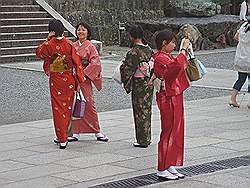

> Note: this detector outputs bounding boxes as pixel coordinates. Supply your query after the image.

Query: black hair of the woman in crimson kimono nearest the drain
[155,30,176,50]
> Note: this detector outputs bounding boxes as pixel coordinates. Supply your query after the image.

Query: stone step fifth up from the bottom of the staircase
[0,24,48,33]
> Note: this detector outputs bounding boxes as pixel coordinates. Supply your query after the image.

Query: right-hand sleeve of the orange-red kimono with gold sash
[72,46,85,83]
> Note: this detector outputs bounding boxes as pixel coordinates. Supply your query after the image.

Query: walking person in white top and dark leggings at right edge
[229,16,250,108]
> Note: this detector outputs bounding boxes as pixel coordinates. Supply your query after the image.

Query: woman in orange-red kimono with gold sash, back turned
[36,20,85,149]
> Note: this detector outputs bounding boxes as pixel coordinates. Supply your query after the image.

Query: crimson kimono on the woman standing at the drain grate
[153,52,189,171]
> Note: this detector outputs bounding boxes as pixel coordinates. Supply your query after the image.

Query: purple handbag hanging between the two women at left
[72,90,86,118]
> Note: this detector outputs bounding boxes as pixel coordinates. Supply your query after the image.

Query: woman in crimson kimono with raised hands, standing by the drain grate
[153,30,190,180]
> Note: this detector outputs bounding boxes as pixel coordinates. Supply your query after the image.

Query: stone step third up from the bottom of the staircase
[0,39,45,48]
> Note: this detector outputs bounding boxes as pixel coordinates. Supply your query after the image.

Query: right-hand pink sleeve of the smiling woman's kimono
[84,45,102,81]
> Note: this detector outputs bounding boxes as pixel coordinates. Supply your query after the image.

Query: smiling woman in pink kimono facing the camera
[71,23,108,142]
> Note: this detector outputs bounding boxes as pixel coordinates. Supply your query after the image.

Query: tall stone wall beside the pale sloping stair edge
[46,0,164,45]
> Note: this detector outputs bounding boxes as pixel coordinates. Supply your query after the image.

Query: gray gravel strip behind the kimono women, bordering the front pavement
[0,68,229,125]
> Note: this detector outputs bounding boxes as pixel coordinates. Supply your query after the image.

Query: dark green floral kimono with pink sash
[120,45,154,146]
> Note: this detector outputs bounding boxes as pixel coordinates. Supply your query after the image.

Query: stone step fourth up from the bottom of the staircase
[0,31,48,40]
